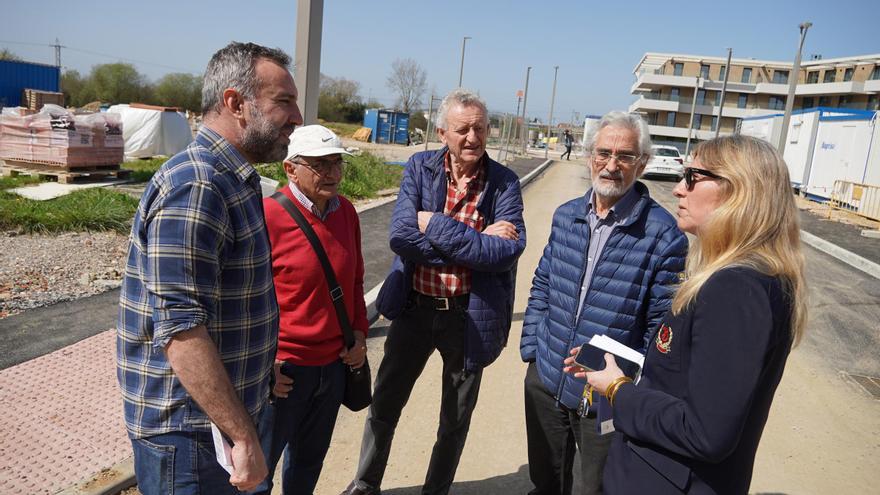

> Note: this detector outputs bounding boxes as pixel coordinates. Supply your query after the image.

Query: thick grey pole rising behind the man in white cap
[294,0,324,125]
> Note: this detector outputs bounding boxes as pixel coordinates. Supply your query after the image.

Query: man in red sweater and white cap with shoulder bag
[255,125,369,494]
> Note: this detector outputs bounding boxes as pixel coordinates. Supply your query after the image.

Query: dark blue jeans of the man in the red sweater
[253,360,346,495]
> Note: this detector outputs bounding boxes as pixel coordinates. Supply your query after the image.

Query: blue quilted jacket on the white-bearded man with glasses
[520,182,687,409]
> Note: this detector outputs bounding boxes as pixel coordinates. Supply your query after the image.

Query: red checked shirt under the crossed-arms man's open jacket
[413,153,486,297]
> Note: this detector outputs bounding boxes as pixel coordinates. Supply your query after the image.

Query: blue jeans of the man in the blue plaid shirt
[131,431,240,495]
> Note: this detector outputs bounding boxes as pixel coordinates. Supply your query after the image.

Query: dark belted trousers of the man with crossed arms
[355,305,482,494]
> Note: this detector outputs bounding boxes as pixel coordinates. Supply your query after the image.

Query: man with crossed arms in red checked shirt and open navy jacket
[343,89,526,495]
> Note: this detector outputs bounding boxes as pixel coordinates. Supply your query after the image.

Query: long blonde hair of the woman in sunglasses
[672,135,807,345]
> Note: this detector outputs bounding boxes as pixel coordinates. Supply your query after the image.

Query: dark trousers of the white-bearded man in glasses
[525,363,612,495]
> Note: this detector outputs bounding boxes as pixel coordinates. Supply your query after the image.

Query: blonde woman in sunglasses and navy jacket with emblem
[566,136,807,494]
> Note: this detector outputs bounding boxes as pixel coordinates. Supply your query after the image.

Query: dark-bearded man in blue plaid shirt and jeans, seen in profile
[116,42,302,495]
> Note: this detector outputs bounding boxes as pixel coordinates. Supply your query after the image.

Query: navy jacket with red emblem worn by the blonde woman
[604,267,791,495]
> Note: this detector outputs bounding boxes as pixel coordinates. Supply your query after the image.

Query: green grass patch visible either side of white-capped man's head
[257,152,403,199]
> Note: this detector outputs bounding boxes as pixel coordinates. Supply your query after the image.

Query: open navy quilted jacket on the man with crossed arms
[376,147,526,371]
